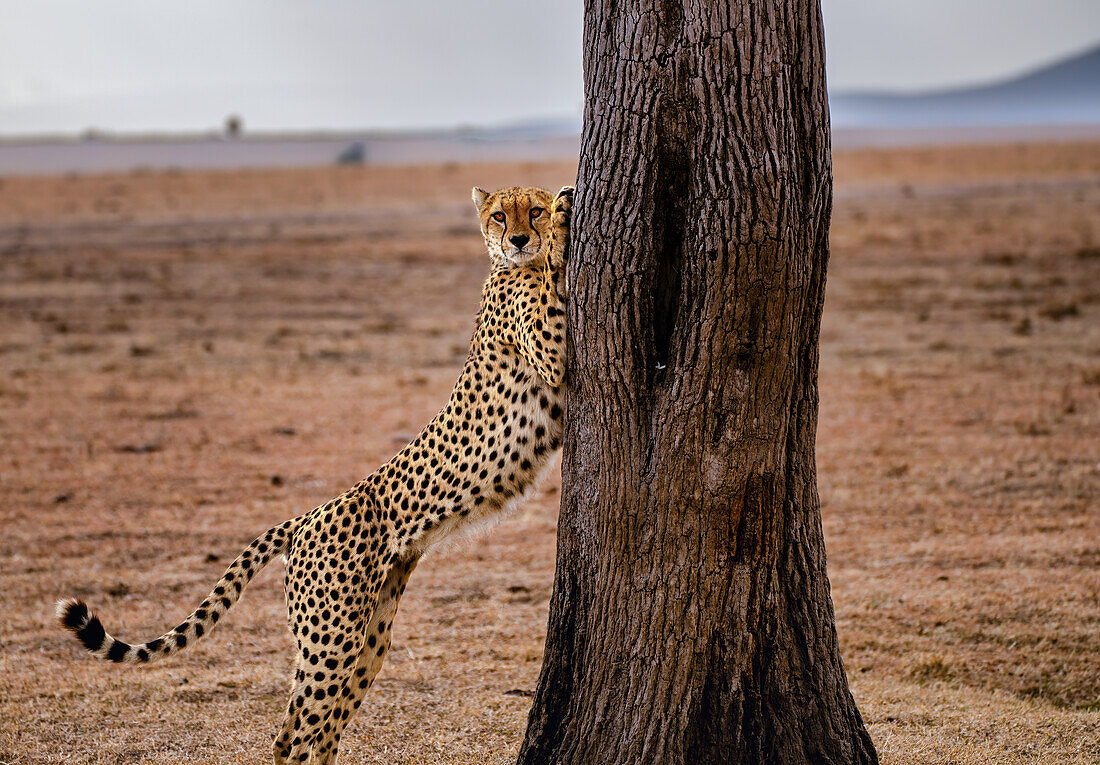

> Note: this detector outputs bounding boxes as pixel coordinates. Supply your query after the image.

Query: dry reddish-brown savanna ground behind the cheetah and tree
[0,142,1100,765]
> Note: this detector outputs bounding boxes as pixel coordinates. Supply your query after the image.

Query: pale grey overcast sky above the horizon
[0,0,1100,134]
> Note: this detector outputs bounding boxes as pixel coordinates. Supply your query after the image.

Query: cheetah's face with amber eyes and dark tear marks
[473,186,553,266]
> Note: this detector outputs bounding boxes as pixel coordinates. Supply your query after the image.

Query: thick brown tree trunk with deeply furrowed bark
[519,0,877,765]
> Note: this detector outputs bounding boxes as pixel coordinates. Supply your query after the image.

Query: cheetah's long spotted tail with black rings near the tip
[57,518,298,664]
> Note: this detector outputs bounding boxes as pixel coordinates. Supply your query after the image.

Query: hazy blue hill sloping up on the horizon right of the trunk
[829,45,1100,128]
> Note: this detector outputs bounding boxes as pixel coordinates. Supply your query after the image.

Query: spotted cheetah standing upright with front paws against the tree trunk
[58,186,573,765]
